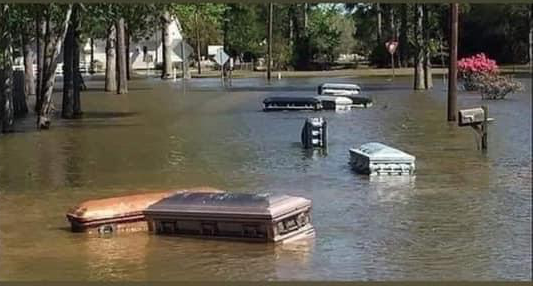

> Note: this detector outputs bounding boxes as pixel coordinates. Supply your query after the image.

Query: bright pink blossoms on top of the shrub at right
[457,53,499,91]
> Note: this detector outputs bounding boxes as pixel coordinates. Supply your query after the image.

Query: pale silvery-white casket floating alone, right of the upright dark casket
[350,142,415,175]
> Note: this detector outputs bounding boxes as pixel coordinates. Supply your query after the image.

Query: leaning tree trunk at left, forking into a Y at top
[37,4,72,129]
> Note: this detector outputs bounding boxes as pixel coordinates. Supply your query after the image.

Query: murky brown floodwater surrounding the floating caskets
[0,72,532,280]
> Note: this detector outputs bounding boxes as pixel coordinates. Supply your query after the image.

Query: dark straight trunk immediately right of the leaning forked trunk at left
[61,21,74,119]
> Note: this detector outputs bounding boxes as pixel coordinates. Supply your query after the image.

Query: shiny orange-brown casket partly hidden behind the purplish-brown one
[66,187,223,233]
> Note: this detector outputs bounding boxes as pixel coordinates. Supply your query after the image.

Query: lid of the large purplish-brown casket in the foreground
[145,192,311,218]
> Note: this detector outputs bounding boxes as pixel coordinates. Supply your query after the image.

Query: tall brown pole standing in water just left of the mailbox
[448,3,459,121]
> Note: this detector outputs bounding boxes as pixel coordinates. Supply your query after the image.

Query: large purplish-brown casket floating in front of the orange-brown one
[144,193,314,242]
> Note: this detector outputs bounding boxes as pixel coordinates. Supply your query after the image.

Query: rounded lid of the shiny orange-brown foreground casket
[67,187,223,222]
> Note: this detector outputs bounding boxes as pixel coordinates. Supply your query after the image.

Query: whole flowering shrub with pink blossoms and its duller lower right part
[457,53,522,99]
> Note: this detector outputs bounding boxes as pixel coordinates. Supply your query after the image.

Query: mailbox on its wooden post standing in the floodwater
[458,106,494,150]
